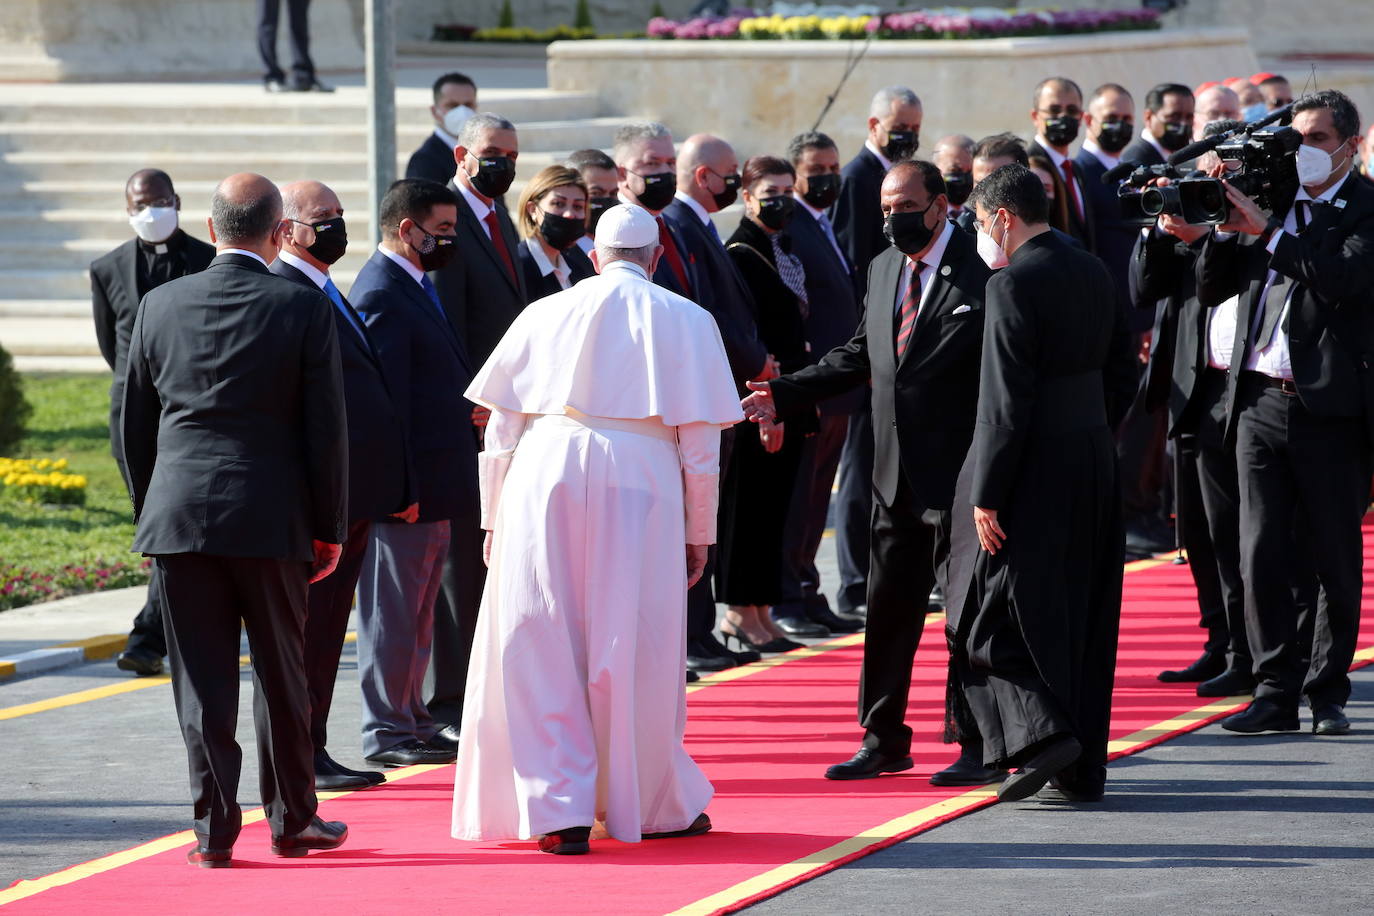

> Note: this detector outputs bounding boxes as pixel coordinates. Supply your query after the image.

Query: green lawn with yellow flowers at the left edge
[0,374,146,610]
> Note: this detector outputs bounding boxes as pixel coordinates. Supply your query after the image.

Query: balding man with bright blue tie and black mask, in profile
[268,181,419,790]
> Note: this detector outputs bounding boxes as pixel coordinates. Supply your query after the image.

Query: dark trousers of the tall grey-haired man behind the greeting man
[835,396,872,611]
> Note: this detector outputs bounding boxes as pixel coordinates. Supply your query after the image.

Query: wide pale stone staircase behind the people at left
[0,76,622,372]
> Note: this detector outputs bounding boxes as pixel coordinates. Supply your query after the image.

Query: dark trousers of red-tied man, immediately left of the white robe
[425,515,486,728]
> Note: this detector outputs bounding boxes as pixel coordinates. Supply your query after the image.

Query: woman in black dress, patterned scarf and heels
[716,157,818,652]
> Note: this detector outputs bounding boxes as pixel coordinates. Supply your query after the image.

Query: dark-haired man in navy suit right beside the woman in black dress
[774,130,864,633]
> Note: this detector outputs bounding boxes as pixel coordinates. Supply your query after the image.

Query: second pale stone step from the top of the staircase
[0,114,624,155]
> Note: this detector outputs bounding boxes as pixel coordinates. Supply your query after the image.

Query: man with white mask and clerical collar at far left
[91,169,214,677]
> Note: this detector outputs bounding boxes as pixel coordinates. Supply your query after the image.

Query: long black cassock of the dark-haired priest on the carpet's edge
[949,232,1136,788]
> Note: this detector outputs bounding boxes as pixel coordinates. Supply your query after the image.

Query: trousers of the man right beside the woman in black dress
[772,413,849,617]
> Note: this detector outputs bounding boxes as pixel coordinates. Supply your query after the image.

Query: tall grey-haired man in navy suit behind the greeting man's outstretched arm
[830,87,923,617]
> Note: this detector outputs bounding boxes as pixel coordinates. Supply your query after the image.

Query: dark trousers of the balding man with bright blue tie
[305,519,372,753]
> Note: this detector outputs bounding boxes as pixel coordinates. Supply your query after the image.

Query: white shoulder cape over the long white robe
[467,262,743,426]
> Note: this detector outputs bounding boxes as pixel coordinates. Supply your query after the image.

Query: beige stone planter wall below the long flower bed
[548,29,1259,158]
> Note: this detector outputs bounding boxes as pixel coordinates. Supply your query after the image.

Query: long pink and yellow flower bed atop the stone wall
[647,10,1160,41]
